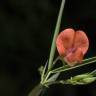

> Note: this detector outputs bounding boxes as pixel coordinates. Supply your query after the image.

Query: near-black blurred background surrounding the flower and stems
[0,0,96,96]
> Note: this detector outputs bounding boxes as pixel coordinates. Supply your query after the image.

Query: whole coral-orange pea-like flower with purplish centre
[56,28,89,66]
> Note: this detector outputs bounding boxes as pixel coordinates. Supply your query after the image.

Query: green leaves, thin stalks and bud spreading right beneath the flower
[39,57,96,87]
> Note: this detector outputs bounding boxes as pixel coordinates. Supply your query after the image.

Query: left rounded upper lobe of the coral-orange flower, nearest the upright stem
[56,28,75,56]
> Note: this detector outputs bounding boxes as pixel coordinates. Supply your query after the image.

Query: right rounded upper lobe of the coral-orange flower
[74,31,89,54]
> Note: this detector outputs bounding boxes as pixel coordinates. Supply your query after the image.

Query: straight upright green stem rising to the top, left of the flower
[48,0,65,70]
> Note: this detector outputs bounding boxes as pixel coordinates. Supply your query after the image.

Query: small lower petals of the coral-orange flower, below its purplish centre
[64,48,83,66]
